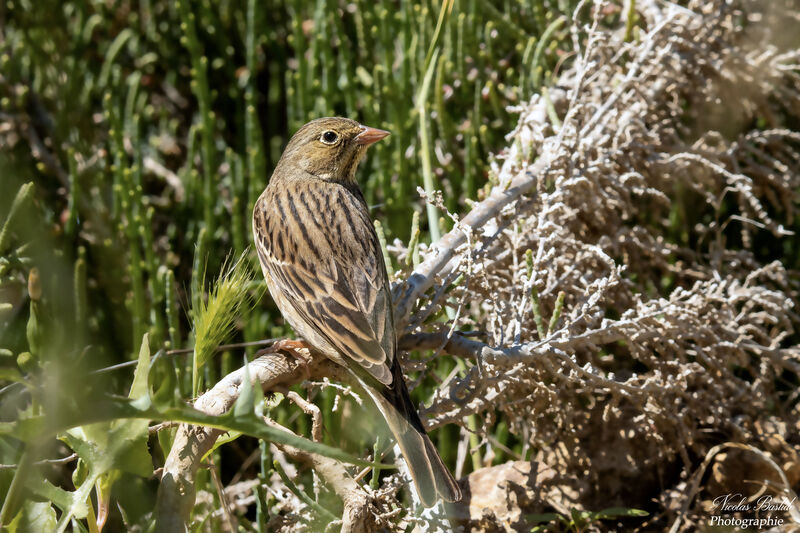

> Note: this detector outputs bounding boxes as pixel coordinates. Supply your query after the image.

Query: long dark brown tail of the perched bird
[362,375,461,507]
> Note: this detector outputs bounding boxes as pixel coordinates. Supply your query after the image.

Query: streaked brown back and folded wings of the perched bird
[254,182,395,385]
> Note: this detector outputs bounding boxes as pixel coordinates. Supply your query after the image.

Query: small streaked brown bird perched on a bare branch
[253,118,461,507]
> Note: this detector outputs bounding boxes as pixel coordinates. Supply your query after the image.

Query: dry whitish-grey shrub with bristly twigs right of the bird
[391,1,800,529]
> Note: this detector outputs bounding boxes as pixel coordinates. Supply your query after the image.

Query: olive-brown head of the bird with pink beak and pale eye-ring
[279,117,389,183]
